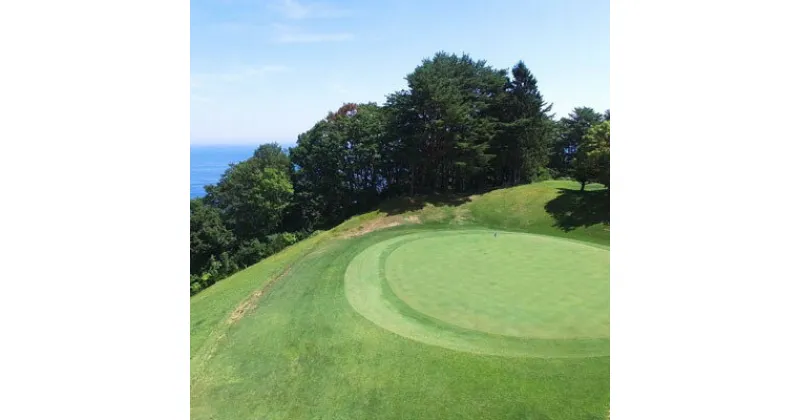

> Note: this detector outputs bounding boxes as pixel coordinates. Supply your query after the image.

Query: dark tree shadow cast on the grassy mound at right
[544,188,611,232]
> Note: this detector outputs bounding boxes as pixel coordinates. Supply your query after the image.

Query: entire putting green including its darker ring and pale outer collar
[345,230,609,357]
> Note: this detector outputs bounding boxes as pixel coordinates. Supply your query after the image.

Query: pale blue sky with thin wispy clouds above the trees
[191,0,610,145]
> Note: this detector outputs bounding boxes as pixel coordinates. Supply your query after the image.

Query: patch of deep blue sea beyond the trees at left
[189,145,258,198]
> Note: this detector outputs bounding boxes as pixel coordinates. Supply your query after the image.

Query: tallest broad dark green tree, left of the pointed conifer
[387,52,507,195]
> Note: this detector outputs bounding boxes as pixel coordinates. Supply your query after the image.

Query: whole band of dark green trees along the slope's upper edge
[190,52,611,294]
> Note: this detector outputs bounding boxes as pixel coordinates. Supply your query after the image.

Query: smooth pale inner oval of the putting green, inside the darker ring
[384,232,609,339]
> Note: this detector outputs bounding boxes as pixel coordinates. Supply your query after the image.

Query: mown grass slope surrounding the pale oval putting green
[191,181,609,419]
